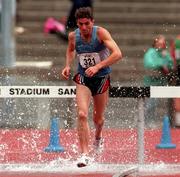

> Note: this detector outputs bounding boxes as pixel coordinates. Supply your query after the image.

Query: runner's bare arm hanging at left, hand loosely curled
[62,32,75,79]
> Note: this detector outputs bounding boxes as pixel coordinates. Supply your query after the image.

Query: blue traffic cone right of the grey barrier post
[156,116,176,149]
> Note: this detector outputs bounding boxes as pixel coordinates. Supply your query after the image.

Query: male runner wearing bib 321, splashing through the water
[62,7,122,167]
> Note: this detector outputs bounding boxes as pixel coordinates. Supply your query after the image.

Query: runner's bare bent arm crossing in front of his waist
[86,27,122,77]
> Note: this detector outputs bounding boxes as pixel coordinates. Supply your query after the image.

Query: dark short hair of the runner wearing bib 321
[75,7,93,20]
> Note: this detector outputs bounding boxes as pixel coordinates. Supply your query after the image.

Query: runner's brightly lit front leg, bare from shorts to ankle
[76,84,91,153]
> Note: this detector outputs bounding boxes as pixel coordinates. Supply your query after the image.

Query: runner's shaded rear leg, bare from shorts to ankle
[93,90,109,139]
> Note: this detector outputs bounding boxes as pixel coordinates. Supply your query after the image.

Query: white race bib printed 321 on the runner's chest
[77,53,101,68]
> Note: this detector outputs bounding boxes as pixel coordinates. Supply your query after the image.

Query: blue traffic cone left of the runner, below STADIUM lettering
[44,118,64,152]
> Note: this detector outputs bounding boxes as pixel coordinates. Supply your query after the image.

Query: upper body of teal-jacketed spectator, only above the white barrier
[144,35,173,86]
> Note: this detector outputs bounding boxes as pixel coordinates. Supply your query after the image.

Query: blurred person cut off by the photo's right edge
[171,35,180,127]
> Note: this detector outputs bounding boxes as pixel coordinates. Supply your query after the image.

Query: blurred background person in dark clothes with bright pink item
[44,0,93,40]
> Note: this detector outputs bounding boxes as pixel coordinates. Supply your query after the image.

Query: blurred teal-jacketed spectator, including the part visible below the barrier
[144,35,173,128]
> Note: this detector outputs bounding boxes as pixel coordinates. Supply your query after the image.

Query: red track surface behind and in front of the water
[0,129,180,177]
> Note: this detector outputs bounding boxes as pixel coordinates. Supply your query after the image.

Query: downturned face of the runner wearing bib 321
[77,18,94,36]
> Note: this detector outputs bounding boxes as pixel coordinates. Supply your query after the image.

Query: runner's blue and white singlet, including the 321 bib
[75,26,111,77]
